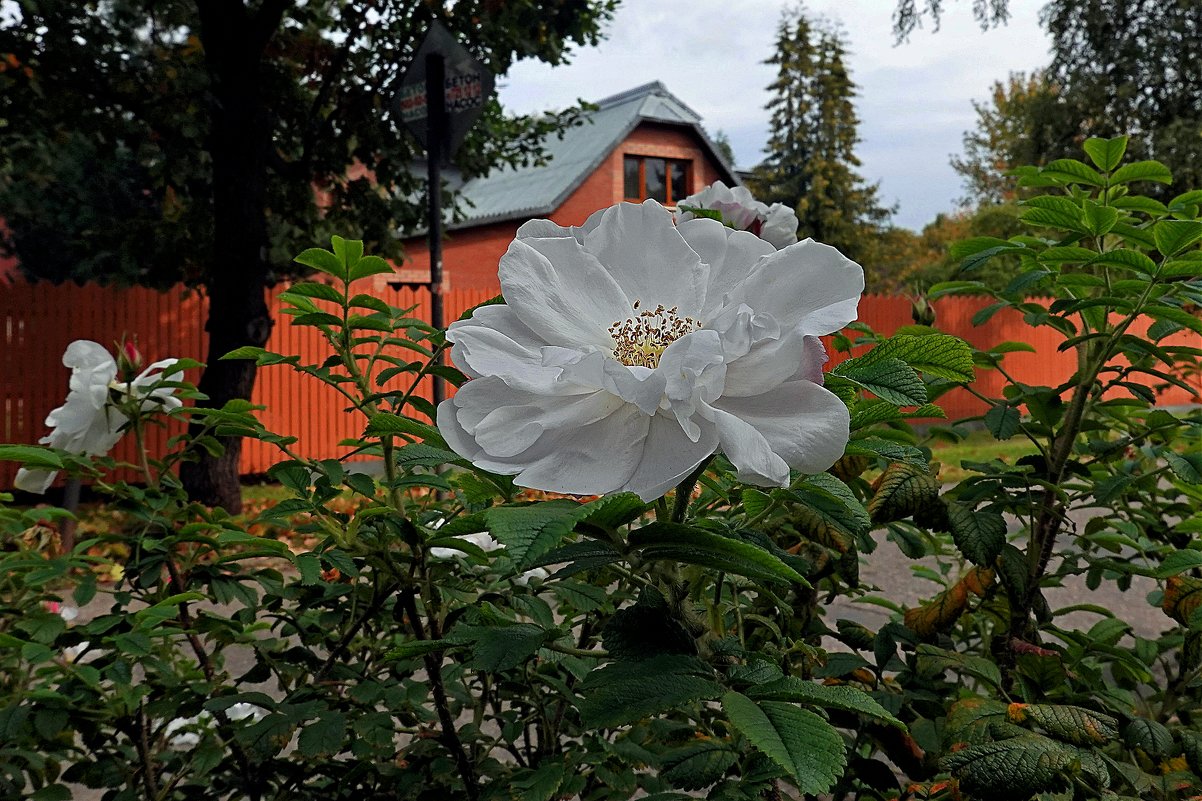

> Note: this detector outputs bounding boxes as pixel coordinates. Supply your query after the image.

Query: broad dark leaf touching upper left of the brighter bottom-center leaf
[579,654,722,729]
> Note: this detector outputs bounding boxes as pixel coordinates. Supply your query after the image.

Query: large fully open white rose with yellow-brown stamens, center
[438,201,864,500]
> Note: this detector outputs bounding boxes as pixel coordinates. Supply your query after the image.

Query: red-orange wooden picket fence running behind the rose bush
[0,277,1202,488]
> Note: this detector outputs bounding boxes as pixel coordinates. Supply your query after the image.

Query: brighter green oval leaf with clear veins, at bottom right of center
[722,693,847,795]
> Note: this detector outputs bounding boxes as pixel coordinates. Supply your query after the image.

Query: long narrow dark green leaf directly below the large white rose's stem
[629,523,809,587]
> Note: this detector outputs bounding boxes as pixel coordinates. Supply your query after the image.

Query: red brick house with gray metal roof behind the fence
[380,82,742,291]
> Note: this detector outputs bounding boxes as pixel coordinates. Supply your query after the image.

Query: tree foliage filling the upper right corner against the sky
[952,0,1202,202]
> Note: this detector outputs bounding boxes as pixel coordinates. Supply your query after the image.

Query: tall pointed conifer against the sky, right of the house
[749,6,892,264]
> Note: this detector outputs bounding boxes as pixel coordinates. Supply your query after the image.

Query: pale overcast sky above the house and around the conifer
[499,0,1048,230]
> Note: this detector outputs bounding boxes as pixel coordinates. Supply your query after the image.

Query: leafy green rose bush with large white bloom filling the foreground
[0,146,1202,801]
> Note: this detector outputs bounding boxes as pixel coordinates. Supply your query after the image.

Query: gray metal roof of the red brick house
[447,81,742,230]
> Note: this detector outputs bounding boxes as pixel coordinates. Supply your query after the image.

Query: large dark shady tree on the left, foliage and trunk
[0,0,617,510]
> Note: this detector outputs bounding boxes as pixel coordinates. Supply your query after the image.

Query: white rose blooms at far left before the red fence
[13,339,183,493]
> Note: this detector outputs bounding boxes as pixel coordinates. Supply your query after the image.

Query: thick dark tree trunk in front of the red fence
[180,0,286,514]
